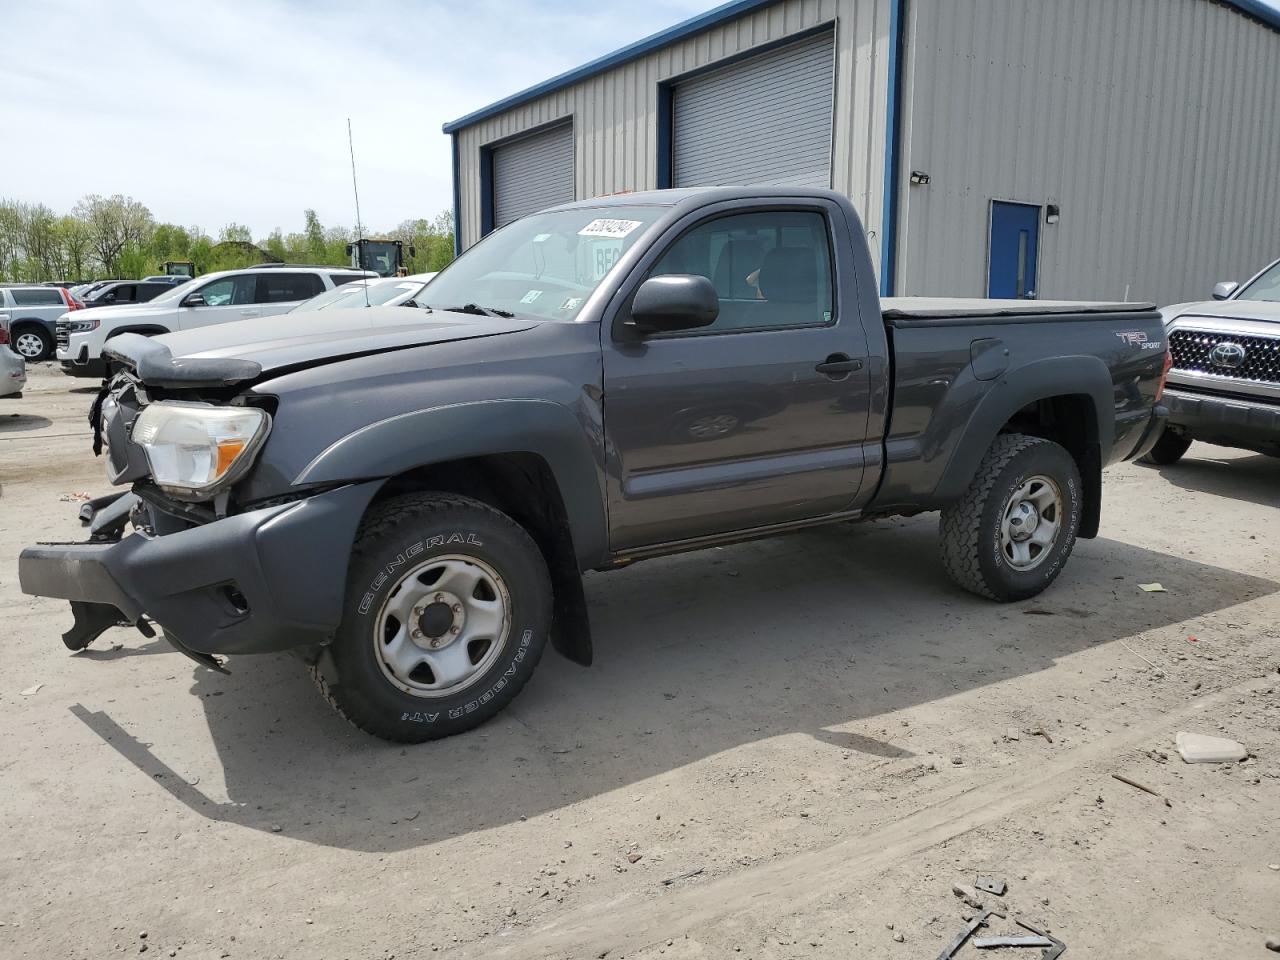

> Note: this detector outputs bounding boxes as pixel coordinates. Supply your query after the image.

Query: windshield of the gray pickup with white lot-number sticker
[419,206,664,320]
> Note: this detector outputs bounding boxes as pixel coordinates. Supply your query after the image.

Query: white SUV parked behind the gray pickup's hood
[56,265,376,376]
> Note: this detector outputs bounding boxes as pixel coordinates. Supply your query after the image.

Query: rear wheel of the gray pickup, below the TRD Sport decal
[940,434,1082,603]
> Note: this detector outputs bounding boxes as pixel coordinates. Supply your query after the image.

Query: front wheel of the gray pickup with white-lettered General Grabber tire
[312,494,552,742]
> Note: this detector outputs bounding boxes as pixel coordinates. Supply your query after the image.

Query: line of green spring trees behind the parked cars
[0,193,453,283]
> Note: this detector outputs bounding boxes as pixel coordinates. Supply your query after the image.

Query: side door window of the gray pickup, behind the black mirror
[649,210,835,335]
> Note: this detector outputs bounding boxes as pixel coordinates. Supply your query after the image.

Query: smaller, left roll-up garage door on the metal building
[493,123,573,227]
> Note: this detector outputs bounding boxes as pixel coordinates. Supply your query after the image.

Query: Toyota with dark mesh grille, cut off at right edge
[1147,260,1280,463]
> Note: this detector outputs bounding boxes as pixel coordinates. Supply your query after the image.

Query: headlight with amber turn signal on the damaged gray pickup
[133,401,271,498]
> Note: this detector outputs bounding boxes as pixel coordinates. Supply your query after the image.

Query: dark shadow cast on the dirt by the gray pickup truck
[73,517,1280,851]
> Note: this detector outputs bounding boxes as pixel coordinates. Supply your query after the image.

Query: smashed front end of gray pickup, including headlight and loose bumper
[19,334,379,669]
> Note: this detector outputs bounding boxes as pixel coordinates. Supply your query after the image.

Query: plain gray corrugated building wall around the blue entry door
[897,0,1280,303]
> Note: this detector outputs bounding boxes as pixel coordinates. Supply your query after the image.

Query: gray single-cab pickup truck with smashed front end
[20,188,1167,741]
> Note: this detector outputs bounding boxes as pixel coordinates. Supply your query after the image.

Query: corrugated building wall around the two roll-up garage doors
[457,0,890,257]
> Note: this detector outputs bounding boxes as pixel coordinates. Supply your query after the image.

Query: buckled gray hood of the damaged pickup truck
[104,307,538,387]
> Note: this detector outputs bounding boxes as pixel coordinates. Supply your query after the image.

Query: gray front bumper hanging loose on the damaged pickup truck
[18,481,381,654]
